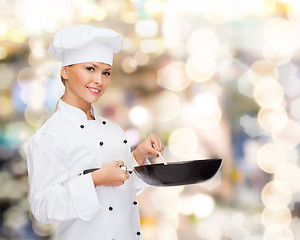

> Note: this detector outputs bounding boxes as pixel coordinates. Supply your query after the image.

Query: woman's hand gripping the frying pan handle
[91,161,129,187]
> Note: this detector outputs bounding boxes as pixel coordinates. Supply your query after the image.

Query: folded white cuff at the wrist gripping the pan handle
[68,173,101,221]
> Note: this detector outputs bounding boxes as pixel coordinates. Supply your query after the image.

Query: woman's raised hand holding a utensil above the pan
[132,133,164,165]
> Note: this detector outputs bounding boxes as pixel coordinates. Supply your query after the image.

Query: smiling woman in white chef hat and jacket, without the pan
[27,26,164,240]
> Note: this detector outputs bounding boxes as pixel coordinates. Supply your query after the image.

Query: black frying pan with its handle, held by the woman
[83,159,222,187]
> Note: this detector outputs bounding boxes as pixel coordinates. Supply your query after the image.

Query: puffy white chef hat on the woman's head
[48,25,123,66]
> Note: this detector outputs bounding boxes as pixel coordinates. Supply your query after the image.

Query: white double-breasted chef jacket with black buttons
[27,100,145,240]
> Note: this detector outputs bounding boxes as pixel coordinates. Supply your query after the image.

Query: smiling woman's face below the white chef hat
[61,62,111,104]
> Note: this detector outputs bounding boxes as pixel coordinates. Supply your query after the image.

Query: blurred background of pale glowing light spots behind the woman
[0,0,300,240]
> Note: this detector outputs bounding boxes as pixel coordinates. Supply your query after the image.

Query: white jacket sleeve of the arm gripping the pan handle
[27,134,101,223]
